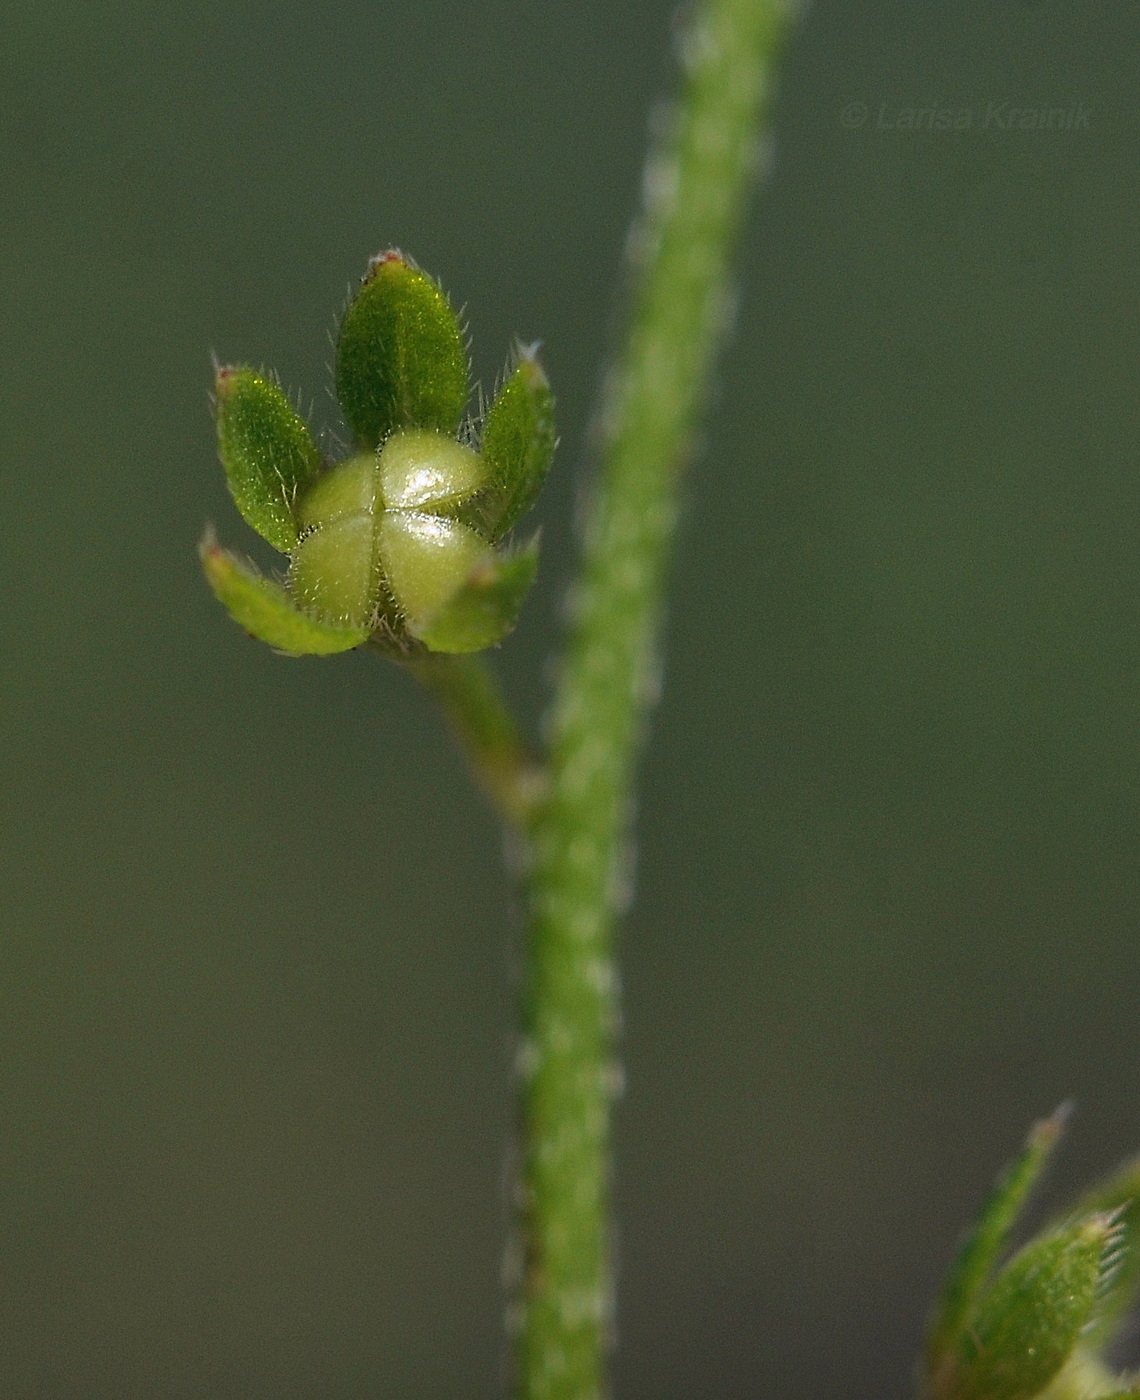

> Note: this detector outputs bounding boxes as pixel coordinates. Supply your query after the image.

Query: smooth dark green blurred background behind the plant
[0,0,1140,1400]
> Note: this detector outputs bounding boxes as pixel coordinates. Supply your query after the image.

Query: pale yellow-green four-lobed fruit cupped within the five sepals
[290,430,492,636]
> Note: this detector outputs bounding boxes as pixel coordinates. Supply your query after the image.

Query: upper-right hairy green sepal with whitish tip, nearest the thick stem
[482,346,555,539]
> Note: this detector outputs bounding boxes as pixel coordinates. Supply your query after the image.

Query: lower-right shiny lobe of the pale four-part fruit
[380,511,492,634]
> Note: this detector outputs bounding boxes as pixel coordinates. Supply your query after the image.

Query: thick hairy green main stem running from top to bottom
[517,0,783,1400]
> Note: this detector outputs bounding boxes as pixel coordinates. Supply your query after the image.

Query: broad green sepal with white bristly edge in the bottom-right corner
[944,1214,1120,1400]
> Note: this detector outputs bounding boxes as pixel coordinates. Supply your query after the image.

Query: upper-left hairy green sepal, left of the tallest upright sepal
[214,365,321,554]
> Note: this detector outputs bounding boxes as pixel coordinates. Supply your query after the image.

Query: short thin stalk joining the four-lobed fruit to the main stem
[401,651,545,832]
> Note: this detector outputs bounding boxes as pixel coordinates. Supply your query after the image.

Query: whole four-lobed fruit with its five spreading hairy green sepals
[210,249,555,661]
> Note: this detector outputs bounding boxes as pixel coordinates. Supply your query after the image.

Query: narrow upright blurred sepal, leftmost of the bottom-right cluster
[926,1105,1069,1389]
